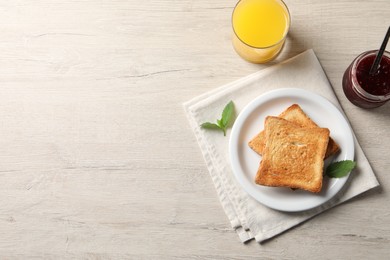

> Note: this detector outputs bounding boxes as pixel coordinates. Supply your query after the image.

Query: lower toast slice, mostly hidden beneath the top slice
[248,104,340,158]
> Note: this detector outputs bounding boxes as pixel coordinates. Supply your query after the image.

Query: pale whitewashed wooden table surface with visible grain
[0,0,390,259]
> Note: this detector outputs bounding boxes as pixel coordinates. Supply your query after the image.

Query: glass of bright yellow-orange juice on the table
[232,0,290,63]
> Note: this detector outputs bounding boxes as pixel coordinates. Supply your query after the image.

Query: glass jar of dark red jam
[343,50,390,108]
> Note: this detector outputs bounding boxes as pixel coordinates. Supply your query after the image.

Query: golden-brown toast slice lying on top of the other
[255,116,329,192]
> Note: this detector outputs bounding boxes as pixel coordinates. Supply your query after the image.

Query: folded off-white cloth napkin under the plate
[183,50,379,242]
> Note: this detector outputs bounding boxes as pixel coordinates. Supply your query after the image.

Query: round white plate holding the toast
[229,88,354,212]
